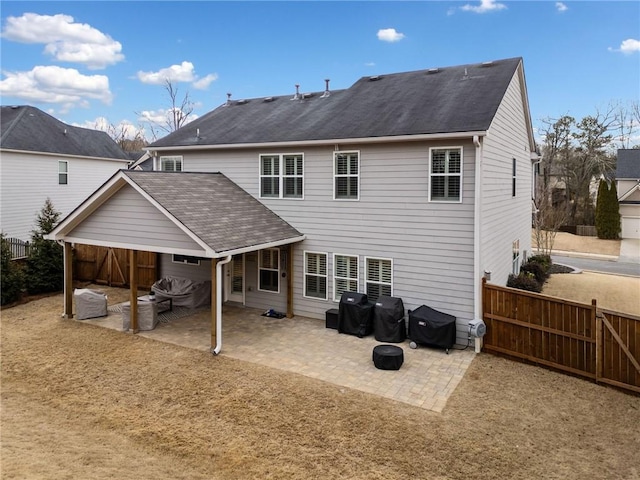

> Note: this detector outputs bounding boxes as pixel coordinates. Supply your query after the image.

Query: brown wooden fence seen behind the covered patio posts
[73,245,158,288]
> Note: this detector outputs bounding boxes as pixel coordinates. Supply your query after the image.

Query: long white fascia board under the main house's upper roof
[149,130,487,153]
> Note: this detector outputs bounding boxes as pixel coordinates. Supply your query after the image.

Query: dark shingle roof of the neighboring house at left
[0,105,129,160]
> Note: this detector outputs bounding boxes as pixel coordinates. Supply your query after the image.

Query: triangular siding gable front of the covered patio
[67,185,204,255]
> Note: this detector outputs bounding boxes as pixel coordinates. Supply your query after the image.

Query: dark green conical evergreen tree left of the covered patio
[26,198,64,294]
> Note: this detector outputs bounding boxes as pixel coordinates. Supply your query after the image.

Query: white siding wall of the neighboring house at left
[0,151,127,240]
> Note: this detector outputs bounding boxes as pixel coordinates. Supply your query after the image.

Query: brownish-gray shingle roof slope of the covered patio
[122,170,302,253]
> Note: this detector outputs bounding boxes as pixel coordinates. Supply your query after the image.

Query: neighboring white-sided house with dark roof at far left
[0,105,130,241]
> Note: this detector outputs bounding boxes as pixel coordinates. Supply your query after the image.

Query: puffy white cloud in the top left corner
[2,13,124,69]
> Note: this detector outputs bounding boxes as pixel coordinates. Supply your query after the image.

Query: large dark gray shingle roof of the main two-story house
[151,58,522,147]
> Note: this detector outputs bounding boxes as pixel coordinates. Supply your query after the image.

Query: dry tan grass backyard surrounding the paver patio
[0,290,640,480]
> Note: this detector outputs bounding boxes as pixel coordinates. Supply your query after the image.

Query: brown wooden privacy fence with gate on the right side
[482,281,640,393]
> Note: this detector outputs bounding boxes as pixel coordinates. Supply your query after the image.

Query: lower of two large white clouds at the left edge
[0,65,113,106]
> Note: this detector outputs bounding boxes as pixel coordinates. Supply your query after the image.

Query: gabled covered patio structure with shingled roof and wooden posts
[48,170,305,354]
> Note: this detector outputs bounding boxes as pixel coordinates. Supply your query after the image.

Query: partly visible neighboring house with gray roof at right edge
[616,149,640,240]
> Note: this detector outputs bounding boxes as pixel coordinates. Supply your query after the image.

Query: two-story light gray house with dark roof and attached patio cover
[53,58,537,350]
